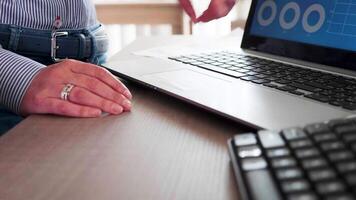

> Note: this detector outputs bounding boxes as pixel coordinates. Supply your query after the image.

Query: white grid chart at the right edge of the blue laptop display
[327,0,356,37]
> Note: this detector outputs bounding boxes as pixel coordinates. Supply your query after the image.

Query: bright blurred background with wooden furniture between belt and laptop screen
[93,0,251,56]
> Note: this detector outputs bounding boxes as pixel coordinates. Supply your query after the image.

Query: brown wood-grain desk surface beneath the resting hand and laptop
[0,35,249,200]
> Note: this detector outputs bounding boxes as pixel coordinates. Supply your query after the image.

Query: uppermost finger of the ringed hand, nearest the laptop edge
[71,61,132,99]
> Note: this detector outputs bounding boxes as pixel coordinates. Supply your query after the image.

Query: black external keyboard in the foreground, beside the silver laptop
[228,118,356,200]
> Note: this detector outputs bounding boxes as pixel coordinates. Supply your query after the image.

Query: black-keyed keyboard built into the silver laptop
[169,52,356,110]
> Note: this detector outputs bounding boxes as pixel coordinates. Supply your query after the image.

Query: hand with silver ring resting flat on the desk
[21,60,132,117]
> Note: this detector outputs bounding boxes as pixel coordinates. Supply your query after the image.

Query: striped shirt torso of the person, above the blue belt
[0,0,97,30]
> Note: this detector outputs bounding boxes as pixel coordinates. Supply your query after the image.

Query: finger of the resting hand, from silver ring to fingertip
[69,87,127,115]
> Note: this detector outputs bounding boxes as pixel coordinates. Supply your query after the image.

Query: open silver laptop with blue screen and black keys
[104,0,356,130]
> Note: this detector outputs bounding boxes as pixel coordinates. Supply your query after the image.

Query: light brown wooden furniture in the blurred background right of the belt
[94,0,191,34]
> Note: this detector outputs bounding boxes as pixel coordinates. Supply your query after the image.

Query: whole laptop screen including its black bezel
[242,0,356,70]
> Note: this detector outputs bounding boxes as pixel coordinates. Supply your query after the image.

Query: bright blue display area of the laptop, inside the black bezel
[250,0,356,51]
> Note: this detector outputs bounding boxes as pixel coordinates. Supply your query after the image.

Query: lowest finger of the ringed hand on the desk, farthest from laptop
[42,98,102,117]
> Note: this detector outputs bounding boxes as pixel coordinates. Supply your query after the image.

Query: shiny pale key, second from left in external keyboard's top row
[258,131,285,149]
